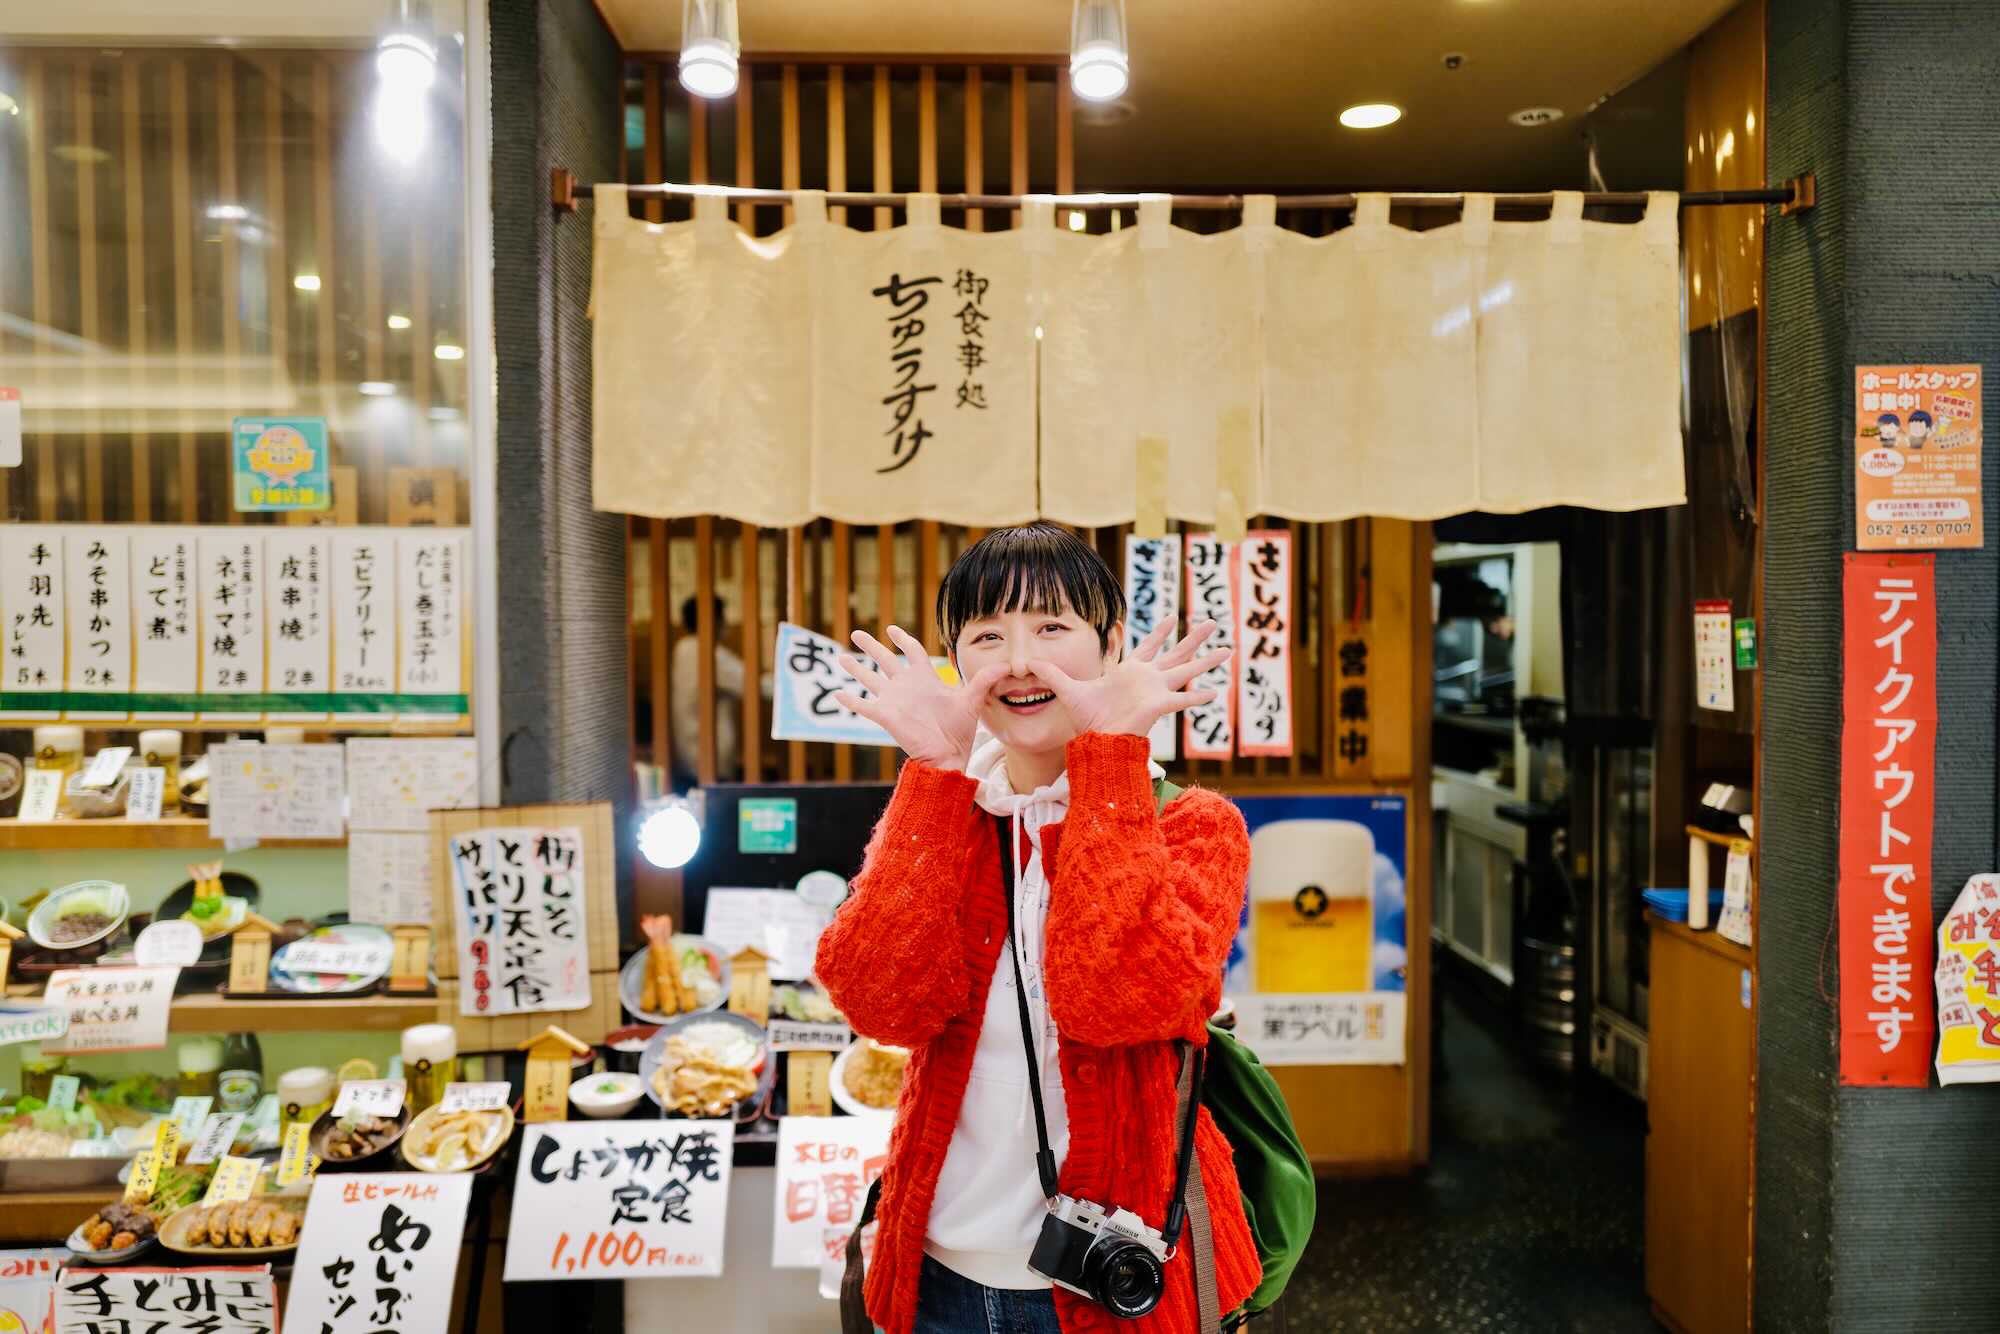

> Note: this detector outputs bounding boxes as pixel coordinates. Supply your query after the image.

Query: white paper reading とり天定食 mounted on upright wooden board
[450,828,590,1016]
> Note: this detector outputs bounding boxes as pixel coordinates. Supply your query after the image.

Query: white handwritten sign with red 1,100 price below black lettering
[506,1120,736,1282]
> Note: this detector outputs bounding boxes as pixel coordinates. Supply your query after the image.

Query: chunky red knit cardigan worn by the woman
[818,734,1262,1334]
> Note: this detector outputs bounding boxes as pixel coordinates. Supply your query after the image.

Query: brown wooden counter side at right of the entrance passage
[1646,914,1756,1334]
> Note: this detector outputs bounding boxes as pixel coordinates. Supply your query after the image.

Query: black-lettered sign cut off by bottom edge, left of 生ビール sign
[56,1264,278,1334]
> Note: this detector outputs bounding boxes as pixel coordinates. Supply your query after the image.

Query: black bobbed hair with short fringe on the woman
[938,524,1124,652]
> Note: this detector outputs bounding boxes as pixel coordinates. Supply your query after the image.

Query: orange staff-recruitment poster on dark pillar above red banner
[1854,366,1986,552]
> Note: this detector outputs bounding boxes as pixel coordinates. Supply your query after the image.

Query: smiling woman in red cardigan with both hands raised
[818,524,1262,1334]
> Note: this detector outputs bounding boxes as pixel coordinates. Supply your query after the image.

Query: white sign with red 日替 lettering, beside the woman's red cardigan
[770,1116,892,1270]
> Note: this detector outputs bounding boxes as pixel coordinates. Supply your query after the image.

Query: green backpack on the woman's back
[1152,778,1316,1328]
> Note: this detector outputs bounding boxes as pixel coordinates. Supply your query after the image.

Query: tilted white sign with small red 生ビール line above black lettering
[284,1172,472,1334]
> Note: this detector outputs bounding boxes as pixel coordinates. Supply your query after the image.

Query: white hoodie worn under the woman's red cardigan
[924,734,1166,1288]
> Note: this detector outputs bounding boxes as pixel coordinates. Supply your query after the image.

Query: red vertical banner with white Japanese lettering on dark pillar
[1840,552,1938,1088]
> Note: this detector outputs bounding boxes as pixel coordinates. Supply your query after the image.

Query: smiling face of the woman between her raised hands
[952,604,1124,754]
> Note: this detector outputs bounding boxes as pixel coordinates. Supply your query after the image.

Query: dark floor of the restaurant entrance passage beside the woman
[1280,1000,1658,1334]
